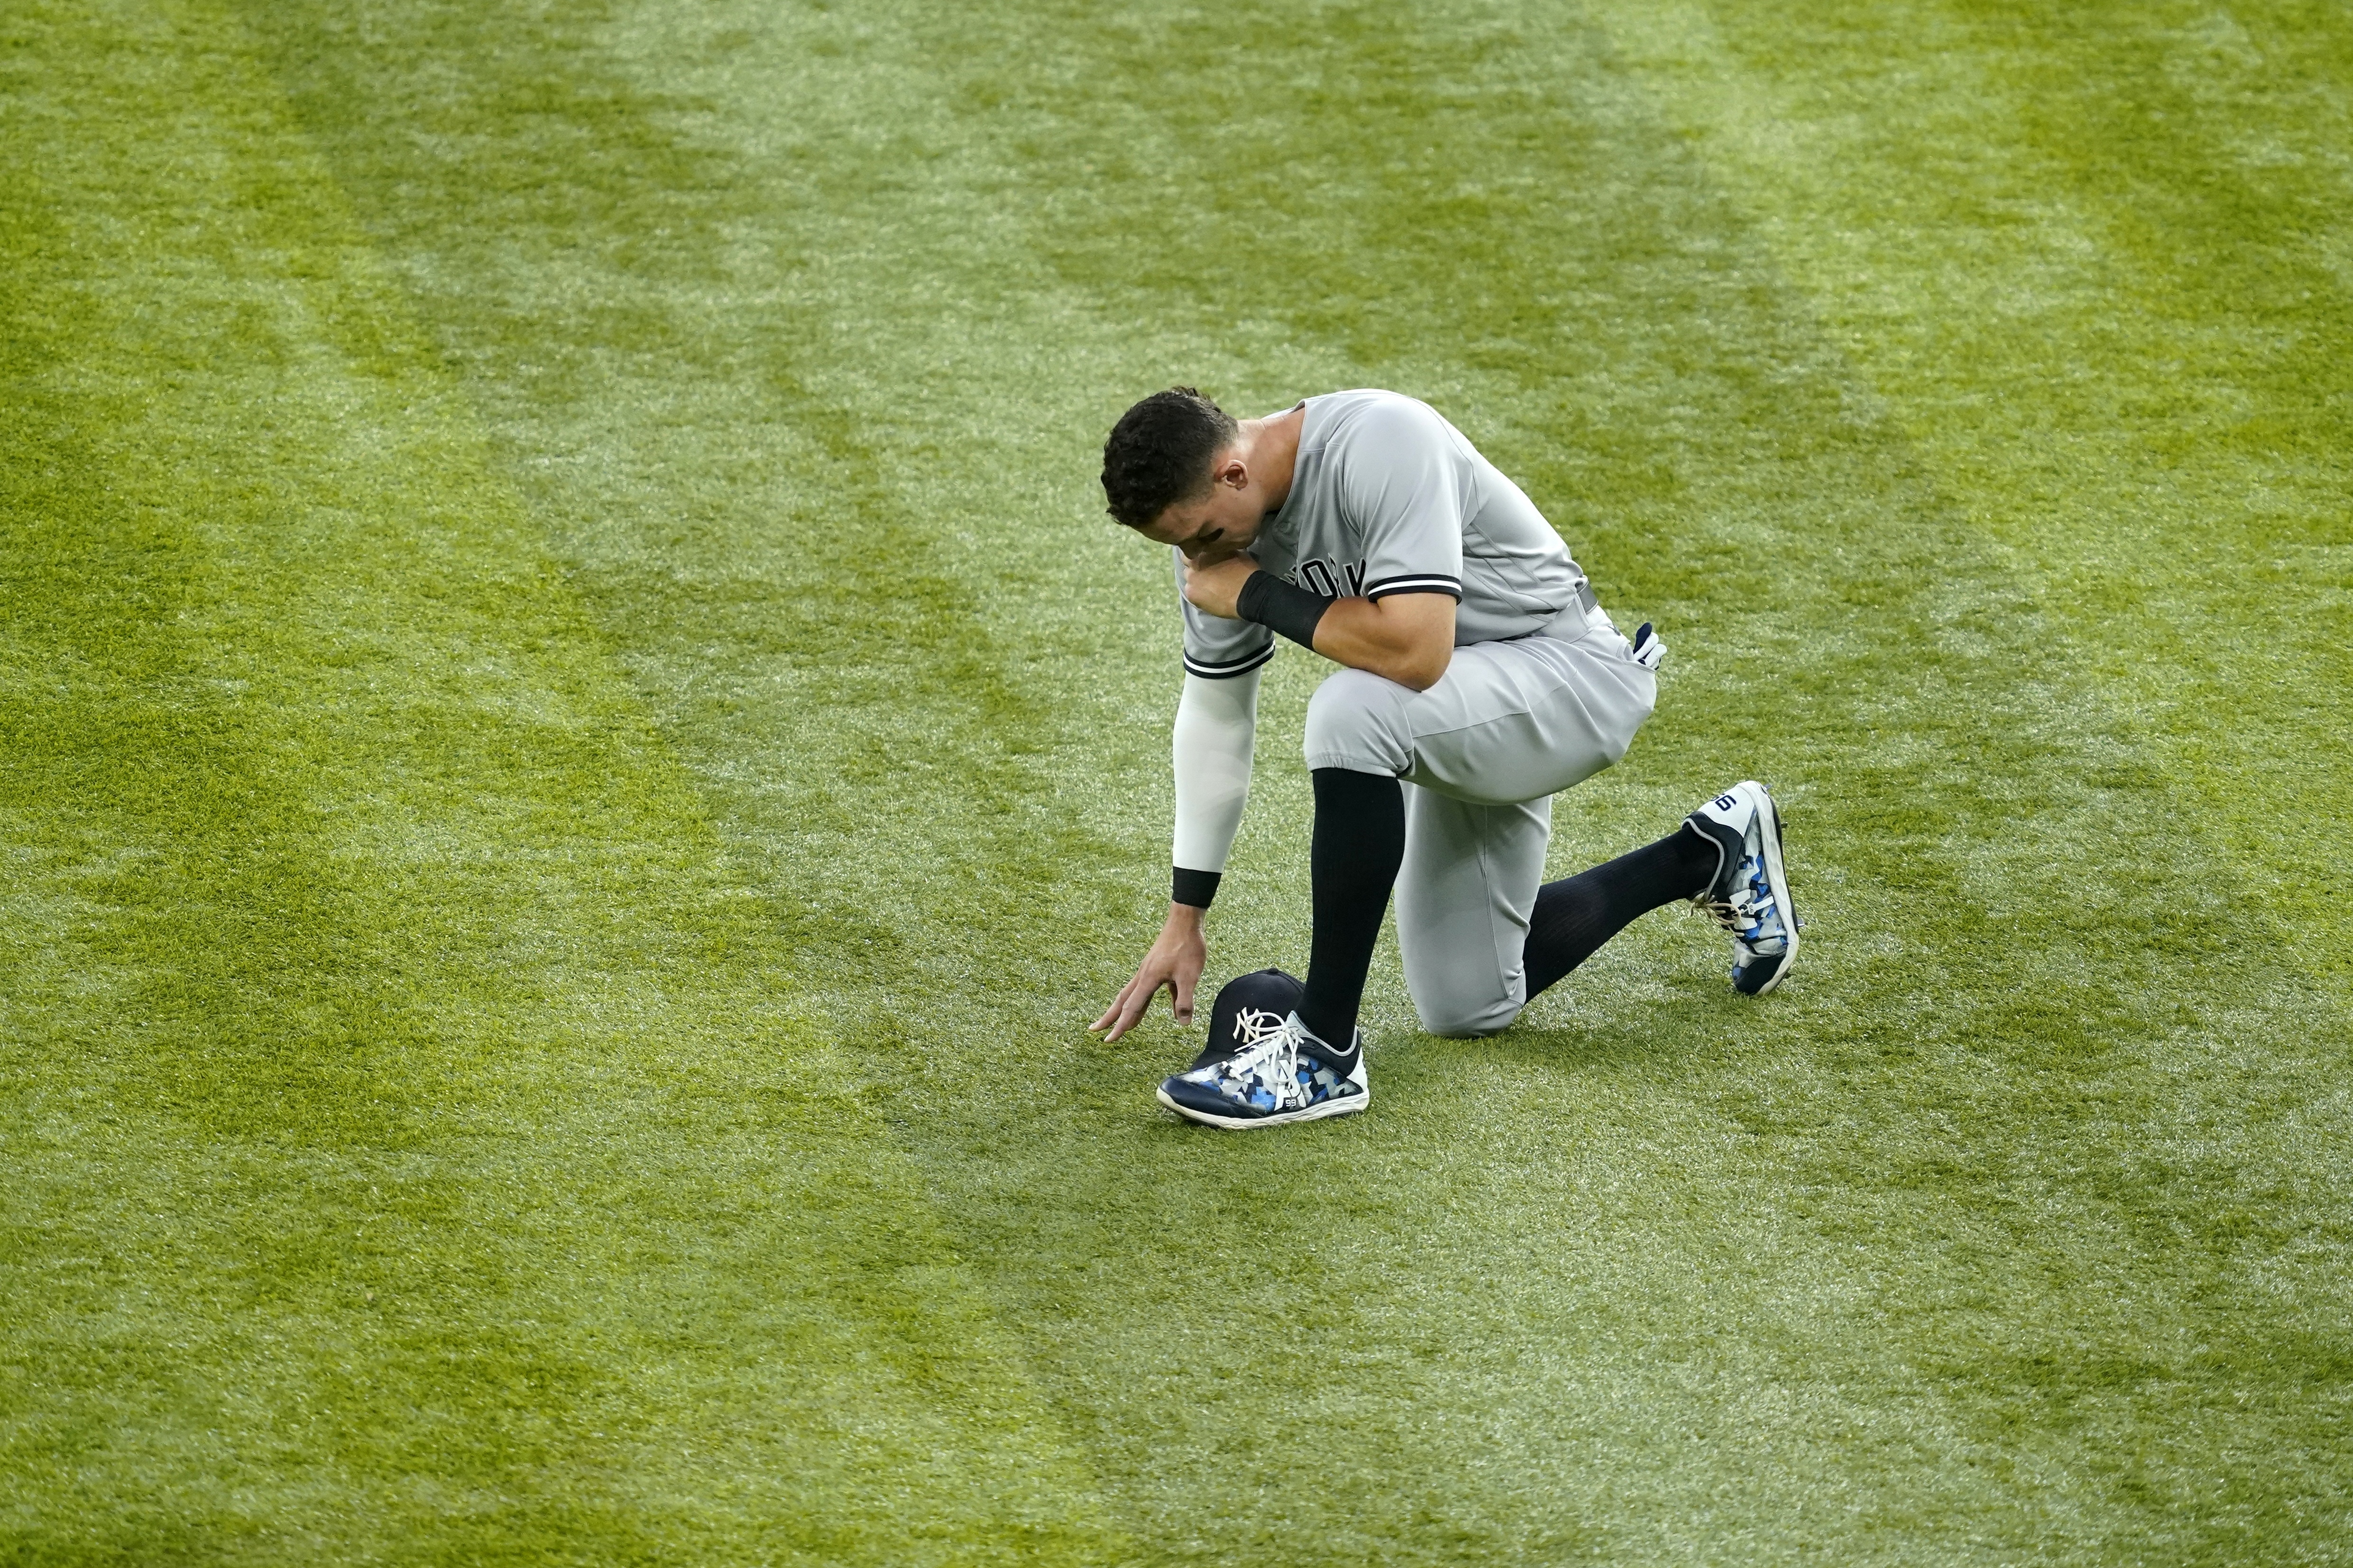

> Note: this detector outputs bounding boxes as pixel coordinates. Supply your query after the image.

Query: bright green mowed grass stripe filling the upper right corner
[1598,5,2353,984]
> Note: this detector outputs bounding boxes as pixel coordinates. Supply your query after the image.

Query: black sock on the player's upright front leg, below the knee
[1299,768,1402,1050]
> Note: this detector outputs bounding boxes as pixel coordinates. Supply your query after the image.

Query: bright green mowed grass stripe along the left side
[0,5,1118,1563]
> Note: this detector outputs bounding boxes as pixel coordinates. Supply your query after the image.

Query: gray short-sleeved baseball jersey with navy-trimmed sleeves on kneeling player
[1174,391,1586,680]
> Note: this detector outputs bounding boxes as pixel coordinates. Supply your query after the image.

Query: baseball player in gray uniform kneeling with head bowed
[1094,386,1798,1128]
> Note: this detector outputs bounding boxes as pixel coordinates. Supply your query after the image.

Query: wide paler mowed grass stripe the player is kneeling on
[234,5,2336,1559]
